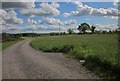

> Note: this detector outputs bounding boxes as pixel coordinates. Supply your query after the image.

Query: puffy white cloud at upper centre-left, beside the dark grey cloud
[20,3,60,17]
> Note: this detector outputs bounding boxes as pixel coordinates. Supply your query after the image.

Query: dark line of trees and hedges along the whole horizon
[0,23,120,42]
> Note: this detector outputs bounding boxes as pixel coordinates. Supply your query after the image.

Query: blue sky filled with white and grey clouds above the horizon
[0,0,119,33]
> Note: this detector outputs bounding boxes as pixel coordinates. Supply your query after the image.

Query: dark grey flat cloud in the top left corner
[2,0,35,8]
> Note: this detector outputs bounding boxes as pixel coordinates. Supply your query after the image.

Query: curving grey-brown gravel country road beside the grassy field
[2,40,97,79]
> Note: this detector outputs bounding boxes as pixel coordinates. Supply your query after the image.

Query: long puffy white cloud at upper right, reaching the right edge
[72,2,120,16]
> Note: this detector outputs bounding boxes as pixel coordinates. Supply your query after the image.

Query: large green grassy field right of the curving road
[31,34,120,78]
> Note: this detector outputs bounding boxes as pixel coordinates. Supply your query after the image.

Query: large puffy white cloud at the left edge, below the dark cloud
[0,9,23,33]
